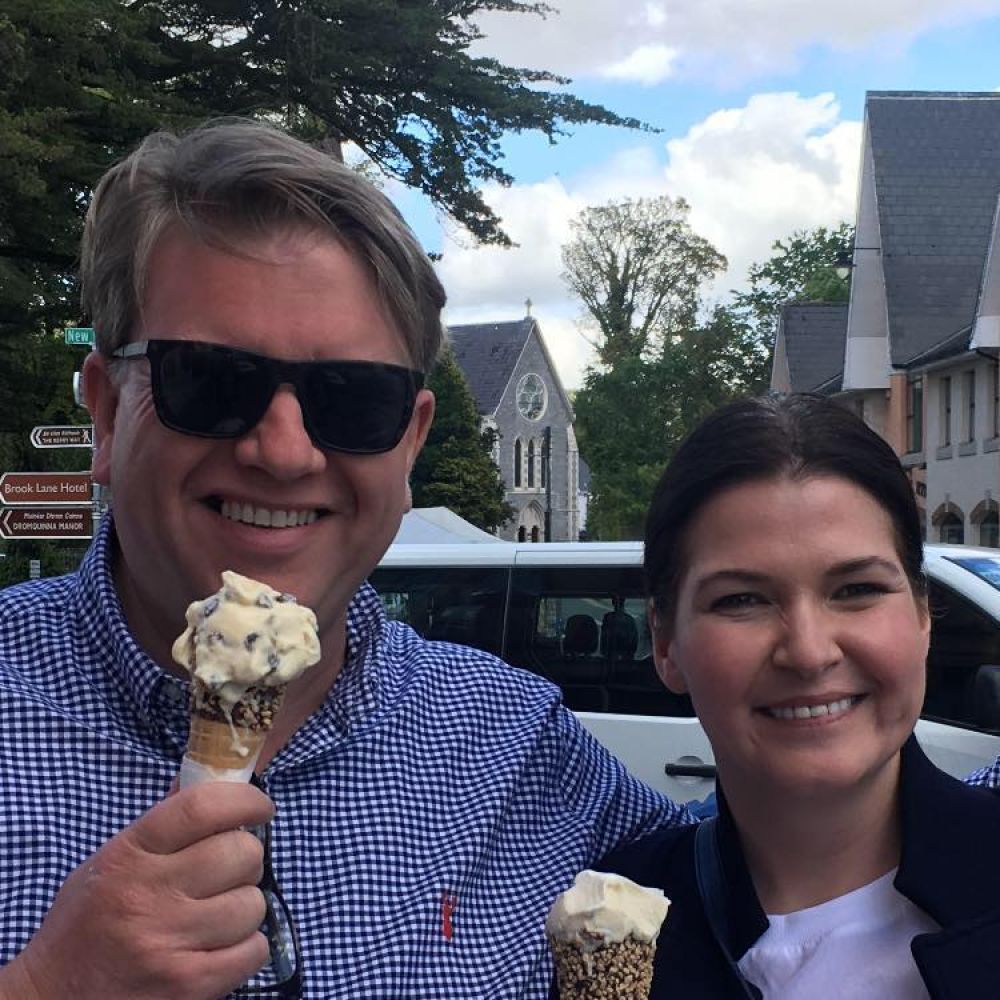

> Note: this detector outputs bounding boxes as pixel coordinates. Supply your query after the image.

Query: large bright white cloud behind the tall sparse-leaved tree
[438,93,861,388]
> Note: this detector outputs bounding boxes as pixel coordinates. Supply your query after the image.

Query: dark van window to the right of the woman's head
[922,580,1000,733]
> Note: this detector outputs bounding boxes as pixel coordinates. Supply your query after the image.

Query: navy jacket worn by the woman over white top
[601,736,1000,1000]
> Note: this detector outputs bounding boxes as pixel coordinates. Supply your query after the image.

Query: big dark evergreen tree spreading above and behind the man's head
[0,0,639,335]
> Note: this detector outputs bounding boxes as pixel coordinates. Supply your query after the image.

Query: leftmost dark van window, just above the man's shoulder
[370,567,509,656]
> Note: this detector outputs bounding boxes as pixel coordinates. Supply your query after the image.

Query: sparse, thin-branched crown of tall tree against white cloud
[562,196,726,366]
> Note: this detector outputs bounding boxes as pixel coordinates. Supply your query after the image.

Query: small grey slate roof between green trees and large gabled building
[779,302,847,392]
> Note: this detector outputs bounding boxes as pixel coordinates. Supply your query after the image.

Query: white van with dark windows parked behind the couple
[371,542,1000,801]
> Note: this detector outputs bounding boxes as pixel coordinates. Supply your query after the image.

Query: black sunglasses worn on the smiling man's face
[111,340,424,455]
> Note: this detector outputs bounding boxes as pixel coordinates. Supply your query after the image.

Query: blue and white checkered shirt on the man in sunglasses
[0,518,690,1000]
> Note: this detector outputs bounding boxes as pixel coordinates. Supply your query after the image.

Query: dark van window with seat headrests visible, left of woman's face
[504,566,694,716]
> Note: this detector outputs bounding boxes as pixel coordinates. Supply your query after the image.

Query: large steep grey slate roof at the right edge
[867,91,1000,366]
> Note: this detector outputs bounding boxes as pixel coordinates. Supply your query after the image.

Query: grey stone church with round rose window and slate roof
[448,316,583,542]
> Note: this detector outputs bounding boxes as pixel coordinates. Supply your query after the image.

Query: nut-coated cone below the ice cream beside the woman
[551,937,655,1000]
